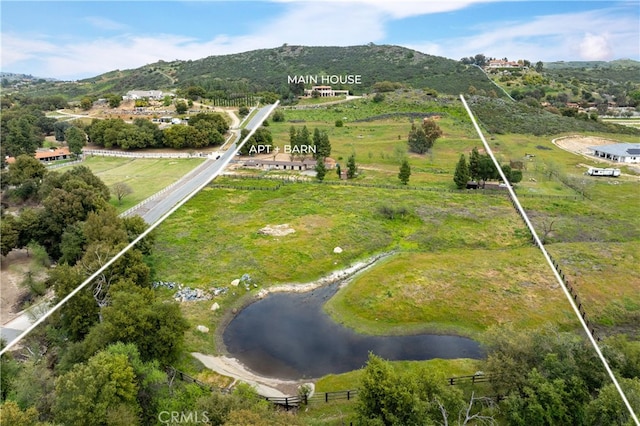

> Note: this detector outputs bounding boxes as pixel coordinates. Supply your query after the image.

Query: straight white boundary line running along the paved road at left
[0,101,280,355]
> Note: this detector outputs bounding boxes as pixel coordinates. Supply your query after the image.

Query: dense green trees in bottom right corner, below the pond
[356,326,640,426]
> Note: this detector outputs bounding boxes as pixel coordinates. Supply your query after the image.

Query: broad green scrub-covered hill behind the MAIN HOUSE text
[8,44,495,100]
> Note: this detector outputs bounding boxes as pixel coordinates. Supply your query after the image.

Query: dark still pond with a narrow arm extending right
[223,284,484,379]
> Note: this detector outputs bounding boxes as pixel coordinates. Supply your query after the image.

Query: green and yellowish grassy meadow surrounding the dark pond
[74,91,640,388]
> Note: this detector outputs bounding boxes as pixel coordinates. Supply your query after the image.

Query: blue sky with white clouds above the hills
[0,0,640,80]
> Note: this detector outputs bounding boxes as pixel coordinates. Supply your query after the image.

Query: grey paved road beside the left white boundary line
[0,102,278,348]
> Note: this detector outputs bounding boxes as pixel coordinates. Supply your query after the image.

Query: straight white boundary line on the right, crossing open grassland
[460,95,640,426]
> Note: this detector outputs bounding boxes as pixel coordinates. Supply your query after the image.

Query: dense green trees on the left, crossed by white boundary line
[0,166,232,425]
